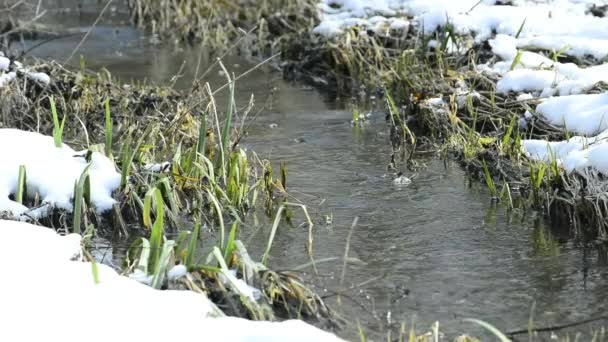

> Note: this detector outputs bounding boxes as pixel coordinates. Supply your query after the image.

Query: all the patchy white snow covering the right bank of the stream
[314,0,608,174]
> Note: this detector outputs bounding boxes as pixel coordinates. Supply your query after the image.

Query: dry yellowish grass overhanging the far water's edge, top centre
[128,0,317,57]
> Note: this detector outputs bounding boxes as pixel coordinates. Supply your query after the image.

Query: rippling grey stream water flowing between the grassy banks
[11,1,608,337]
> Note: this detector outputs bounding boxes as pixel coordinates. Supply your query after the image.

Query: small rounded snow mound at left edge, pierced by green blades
[0,128,120,218]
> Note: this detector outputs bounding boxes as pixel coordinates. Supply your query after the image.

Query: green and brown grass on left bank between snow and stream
[0,48,334,324]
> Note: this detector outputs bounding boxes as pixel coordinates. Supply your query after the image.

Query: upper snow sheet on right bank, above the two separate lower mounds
[314,0,608,97]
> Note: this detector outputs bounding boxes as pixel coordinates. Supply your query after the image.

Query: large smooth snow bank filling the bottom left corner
[0,220,340,342]
